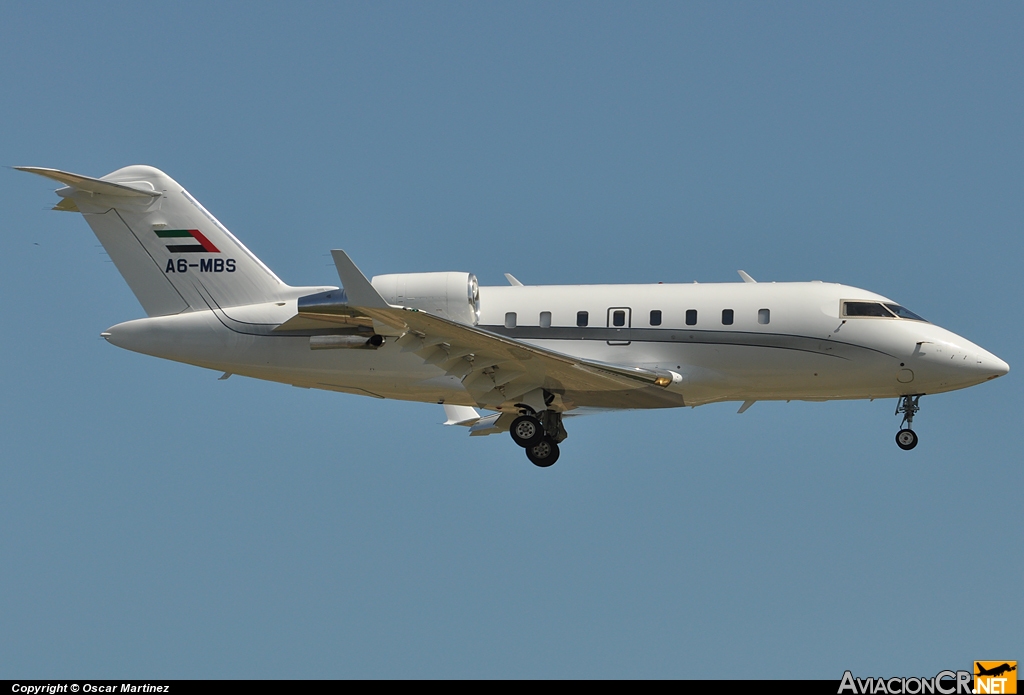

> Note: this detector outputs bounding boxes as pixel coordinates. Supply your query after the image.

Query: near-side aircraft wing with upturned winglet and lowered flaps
[303,251,682,409]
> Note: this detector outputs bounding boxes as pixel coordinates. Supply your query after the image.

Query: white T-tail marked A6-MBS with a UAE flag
[15,166,294,316]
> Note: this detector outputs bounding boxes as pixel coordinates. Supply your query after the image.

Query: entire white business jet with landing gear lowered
[17,166,1010,467]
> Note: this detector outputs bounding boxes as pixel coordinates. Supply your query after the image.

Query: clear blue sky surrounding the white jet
[0,2,1024,679]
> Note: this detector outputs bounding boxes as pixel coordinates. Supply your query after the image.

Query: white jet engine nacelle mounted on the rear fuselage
[370,272,480,325]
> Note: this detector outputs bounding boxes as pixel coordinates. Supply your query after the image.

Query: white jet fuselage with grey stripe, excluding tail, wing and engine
[104,283,1009,407]
